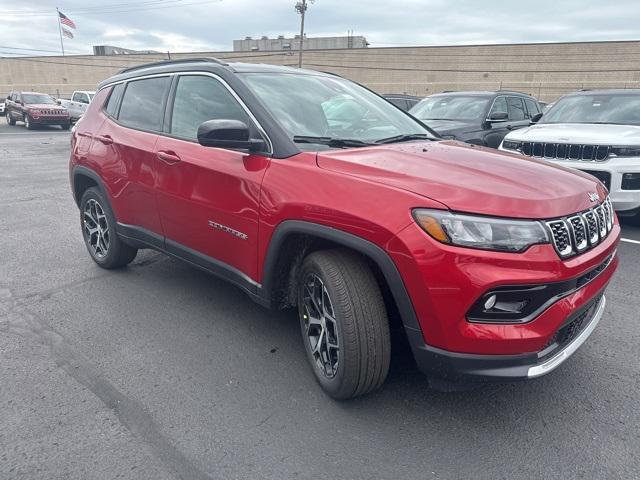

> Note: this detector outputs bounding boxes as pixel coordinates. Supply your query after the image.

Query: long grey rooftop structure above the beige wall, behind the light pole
[233,35,369,52]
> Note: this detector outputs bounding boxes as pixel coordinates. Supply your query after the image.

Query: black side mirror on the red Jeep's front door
[198,120,264,152]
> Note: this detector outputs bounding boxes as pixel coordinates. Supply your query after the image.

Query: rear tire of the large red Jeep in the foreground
[80,187,138,269]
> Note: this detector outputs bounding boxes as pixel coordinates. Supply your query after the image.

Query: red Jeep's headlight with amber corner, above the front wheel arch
[413,209,549,252]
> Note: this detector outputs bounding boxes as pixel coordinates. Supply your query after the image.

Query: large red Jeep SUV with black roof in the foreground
[70,59,620,398]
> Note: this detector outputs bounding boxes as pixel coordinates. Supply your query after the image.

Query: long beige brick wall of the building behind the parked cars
[0,41,640,101]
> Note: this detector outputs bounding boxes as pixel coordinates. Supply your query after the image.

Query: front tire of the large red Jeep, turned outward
[298,249,391,399]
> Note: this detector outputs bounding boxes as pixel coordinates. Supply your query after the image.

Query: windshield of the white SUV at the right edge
[540,93,640,125]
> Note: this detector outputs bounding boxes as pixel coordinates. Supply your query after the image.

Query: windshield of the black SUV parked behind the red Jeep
[409,95,490,121]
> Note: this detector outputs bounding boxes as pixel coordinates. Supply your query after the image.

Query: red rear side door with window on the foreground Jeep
[92,76,171,239]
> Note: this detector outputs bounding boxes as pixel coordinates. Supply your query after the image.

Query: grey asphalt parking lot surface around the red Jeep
[0,119,640,480]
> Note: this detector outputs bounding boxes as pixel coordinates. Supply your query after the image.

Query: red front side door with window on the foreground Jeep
[156,74,269,280]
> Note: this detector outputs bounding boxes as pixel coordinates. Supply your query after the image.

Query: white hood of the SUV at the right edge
[506,123,640,145]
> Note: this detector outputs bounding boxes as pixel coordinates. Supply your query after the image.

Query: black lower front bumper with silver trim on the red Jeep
[406,293,606,382]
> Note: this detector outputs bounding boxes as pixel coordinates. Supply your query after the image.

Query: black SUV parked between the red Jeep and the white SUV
[409,90,542,148]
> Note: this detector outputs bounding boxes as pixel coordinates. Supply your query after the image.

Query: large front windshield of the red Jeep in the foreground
[244,73,434,143]
